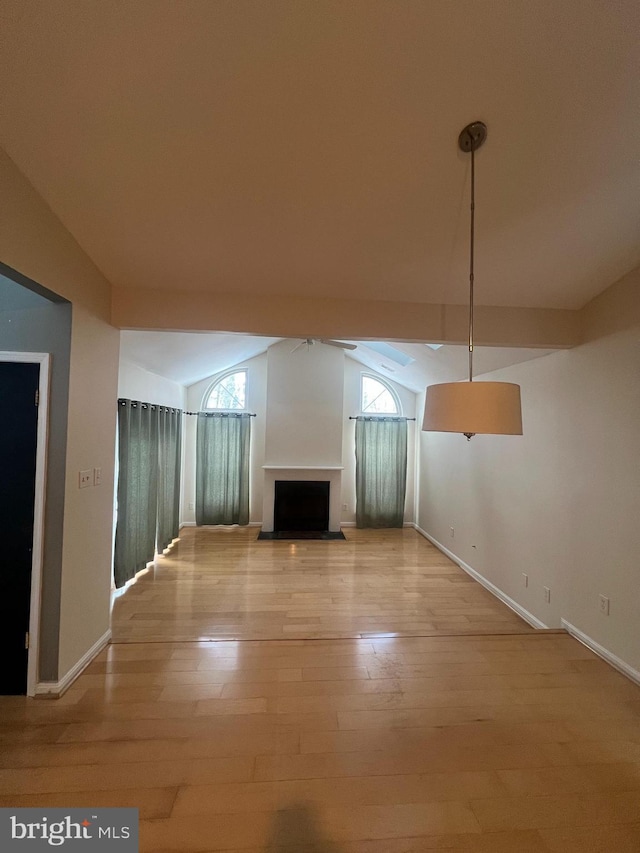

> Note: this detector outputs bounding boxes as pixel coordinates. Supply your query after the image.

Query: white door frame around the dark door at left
[0,351,51,696]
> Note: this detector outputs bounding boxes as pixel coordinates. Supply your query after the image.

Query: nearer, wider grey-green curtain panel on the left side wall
[114,400,158,587]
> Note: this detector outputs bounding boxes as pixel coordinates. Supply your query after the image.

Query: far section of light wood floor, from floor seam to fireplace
[112,527,533,642]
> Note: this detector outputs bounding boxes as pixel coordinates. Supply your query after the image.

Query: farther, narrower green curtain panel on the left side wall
[156,406,182,554]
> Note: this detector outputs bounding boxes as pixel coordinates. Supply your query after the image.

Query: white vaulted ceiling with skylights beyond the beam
[120,331,552,391]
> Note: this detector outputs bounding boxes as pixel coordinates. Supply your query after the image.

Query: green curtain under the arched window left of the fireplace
[196,412,251,524]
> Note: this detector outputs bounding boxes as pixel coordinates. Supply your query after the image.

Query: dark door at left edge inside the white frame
[0,361,40,695]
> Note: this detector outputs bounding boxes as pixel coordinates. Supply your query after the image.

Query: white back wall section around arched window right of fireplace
[342,358,419,524]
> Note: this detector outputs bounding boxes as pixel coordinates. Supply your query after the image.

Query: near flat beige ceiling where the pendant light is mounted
[0,0,640,308]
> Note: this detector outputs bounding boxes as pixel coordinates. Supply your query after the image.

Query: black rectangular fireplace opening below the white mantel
[273,480,330,533]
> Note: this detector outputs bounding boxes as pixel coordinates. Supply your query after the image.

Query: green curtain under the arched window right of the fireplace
[356,417,407,527]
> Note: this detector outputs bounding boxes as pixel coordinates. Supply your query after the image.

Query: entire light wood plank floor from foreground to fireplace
[0,531,640,853]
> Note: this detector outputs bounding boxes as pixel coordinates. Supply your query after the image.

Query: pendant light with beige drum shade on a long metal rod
[422,121,522,440]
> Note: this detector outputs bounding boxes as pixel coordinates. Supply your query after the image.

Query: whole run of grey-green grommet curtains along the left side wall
[114,400,182,588]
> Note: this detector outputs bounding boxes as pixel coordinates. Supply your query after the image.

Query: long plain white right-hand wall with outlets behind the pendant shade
[418,327,640,670]
